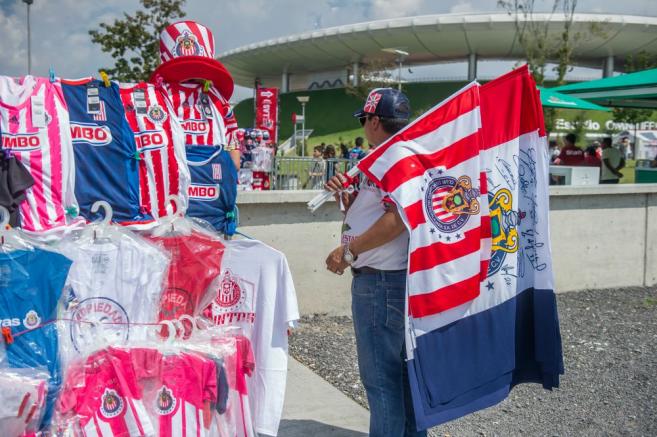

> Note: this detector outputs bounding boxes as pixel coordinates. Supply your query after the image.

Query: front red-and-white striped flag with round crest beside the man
[358,83,490,318]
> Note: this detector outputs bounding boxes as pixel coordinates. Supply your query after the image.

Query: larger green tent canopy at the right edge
[551,68,657,109]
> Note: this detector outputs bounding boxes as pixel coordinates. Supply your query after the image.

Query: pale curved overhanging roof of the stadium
[219,13,657,86]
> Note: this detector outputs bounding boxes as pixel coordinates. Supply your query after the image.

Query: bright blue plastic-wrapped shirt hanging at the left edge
[0,249,71,425]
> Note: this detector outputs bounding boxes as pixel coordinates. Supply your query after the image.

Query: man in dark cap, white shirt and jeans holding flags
[326,88,426,437]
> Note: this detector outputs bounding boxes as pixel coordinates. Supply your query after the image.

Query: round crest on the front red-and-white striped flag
[424,176,481,232]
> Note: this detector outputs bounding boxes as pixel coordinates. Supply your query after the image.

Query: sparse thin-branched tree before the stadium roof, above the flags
[497,0,603,132]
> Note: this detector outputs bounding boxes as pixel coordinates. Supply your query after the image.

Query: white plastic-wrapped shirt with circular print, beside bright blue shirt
[59,236,168,362]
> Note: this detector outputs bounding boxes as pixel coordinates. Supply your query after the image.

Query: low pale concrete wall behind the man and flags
[238,184,657,315]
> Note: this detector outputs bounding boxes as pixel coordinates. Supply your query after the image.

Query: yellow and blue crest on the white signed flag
[488,188,525,276]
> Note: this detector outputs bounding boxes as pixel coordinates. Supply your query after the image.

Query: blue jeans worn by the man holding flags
[351,271,427,437]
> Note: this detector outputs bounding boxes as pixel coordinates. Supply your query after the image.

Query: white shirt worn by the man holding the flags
[342,175,408,270]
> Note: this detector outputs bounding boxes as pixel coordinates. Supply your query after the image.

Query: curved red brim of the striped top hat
[150,56,235,100]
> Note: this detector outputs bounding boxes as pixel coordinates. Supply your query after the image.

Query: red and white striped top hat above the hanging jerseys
[151,21,235,100]
